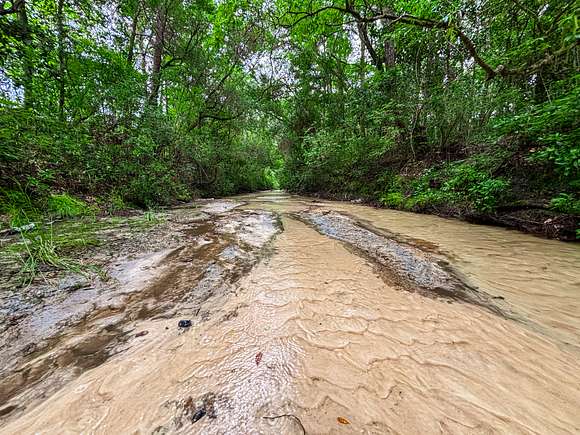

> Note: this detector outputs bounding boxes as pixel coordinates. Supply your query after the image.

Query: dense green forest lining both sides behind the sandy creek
[0,0,580,239]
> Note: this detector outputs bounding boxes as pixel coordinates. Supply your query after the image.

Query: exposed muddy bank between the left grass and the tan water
[0,201,279,426]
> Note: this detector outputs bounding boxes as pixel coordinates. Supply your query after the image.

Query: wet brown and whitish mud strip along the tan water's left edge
[0,209,281,421]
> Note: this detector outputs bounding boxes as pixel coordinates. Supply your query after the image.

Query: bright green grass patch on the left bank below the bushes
[0,190,162,287]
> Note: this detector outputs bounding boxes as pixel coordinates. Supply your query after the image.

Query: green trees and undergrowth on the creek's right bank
[278,1,580,238]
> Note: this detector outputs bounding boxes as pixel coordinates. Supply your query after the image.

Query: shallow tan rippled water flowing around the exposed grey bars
[0,192,580,434]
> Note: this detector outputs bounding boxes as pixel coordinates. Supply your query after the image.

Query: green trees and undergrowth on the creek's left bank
[0,0,282,226]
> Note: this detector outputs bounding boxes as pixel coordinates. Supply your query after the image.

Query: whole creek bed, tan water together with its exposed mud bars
[0,192,580,434]
